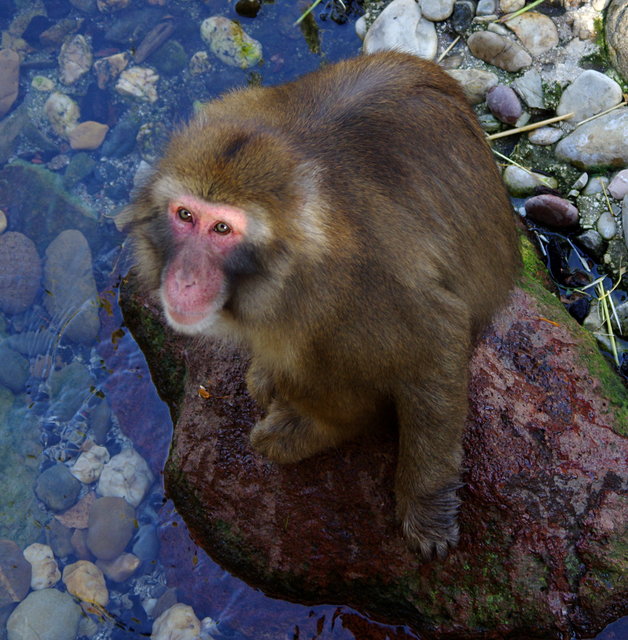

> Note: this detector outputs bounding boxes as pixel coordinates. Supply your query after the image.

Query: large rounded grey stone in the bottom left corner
[7,589,82,640]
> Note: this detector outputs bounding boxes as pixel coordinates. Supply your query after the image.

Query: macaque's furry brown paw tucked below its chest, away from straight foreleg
[250,401,334,463]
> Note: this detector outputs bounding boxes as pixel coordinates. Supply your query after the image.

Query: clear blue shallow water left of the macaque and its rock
[0,0,624,640]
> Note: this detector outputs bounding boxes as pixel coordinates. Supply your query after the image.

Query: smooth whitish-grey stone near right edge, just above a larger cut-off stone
[556,69,623,126]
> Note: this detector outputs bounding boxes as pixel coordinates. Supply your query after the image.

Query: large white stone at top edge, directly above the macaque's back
[363,0,422,55]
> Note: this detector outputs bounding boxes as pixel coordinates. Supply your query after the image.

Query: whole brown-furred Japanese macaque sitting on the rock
[121,52,519,559]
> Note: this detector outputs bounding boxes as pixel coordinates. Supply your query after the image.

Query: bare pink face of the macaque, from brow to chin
[161,195,247,333]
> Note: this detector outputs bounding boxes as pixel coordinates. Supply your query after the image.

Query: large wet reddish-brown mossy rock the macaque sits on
[120,252,628,638]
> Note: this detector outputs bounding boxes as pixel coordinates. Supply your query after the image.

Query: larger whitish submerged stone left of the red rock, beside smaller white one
[97,449,153,507]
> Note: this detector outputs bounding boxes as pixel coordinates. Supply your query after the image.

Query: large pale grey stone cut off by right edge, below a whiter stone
[555,107,628,169]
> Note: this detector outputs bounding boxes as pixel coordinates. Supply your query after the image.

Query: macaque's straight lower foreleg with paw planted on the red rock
[395,376,467,560]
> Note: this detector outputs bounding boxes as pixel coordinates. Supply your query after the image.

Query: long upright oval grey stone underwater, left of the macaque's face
[44,229,100,344]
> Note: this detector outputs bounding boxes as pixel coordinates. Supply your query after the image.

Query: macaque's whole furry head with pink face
[119,116,332,334]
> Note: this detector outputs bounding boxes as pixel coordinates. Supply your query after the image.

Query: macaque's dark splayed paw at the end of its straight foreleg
[397,483,462,561]
